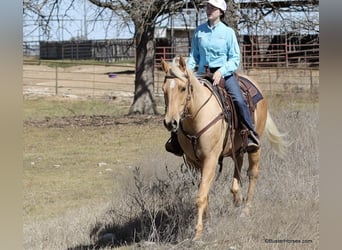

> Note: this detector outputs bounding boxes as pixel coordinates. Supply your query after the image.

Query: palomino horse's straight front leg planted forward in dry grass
[194,157,218,240]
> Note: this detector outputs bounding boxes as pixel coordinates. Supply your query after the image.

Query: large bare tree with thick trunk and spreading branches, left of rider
[24,0,188,114]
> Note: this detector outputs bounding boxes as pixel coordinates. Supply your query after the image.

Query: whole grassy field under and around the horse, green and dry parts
[23,69,319,250]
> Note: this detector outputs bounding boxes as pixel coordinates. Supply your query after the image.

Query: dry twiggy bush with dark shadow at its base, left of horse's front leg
[68,168,196,250]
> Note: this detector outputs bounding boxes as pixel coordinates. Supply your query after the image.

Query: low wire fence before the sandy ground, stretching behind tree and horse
[23,60,319,100]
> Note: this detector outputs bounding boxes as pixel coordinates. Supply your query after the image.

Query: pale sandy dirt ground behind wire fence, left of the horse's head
[23,64,163,98]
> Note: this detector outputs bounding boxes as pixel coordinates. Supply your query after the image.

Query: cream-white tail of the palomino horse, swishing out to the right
[265,112,289,157]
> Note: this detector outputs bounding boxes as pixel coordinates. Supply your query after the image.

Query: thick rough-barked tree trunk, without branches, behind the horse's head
[129,26,158,115]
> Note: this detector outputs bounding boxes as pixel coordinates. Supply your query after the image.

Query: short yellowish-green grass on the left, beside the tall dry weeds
[23,125,166,221]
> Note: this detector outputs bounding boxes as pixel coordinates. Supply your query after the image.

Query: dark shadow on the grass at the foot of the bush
[68,209,193,250]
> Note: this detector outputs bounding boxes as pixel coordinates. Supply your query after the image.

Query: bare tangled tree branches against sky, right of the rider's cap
[236,0,319,35]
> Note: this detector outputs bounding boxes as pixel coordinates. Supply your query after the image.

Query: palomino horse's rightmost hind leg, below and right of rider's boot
[243,149,261,215]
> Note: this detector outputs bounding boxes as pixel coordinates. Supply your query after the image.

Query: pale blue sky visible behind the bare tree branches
[23,0,314,41]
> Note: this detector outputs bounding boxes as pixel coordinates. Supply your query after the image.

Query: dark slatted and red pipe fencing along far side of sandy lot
[23,39,319,69]
